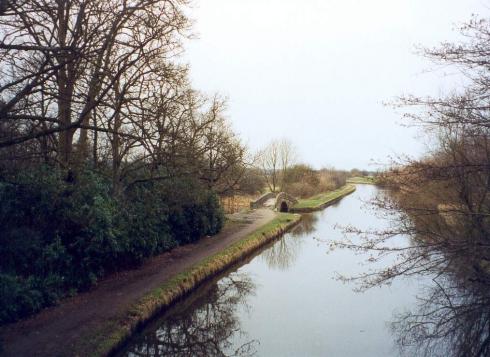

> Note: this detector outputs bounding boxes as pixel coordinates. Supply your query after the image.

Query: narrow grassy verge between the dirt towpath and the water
[75,213,301,356]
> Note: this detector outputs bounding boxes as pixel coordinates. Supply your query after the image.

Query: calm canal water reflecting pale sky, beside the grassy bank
[120,185,424,357]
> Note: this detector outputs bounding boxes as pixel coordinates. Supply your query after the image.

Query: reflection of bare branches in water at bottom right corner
[392,262,490,356]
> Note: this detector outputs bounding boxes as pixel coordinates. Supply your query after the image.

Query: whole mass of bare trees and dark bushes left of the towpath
[0,0,245,323]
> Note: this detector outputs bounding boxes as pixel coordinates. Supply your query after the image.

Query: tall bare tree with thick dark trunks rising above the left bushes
[0,0,188,165]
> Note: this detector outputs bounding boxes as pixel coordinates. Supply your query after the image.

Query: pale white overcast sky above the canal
[186,0,490,169]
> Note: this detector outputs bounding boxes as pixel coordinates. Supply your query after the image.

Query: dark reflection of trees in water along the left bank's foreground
[123,273,258,356]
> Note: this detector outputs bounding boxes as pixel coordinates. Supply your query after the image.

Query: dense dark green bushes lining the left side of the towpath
[0,166,224,323]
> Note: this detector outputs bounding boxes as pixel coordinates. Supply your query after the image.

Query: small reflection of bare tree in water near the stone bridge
[261,214,318,270]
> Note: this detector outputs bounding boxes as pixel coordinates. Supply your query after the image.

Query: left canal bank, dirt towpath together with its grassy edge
[0,209,300,357]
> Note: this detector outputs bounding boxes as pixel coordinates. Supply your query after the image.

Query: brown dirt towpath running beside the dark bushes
[0,209,275,357]
